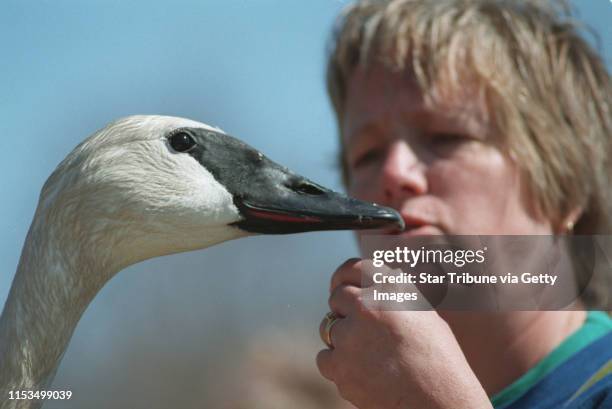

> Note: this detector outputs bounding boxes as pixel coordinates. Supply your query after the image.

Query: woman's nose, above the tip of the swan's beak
[381,141,427,206]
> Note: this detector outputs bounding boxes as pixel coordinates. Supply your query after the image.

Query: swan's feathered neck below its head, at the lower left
[0,218,109,409]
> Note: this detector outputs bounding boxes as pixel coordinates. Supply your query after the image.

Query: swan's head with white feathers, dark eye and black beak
[38,116,402,264]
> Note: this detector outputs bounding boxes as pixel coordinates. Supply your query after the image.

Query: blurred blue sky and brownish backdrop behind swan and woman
[0,0,612,409]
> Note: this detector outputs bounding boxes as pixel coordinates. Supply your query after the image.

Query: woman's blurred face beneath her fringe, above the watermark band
[342,68,552,235]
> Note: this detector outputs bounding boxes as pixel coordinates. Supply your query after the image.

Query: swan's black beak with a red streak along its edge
[182,128,404,234]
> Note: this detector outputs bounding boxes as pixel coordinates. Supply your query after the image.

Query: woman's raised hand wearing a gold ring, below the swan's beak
[317,259,492,409]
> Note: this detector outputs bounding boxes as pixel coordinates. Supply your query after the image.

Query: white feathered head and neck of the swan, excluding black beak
[0,116,247,409]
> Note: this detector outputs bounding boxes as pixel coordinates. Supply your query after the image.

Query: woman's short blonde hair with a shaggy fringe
[327,0,612,234]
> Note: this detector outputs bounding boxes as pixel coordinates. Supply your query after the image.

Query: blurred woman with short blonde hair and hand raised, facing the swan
[317,0,612,409]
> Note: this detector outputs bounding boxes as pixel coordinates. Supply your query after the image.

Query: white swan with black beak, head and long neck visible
[0,115,403,409]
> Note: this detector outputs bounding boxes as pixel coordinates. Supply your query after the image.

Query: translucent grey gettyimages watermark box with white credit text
[360,235,612,311]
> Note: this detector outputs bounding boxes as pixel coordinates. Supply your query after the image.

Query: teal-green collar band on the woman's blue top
[491,311,612,408]
